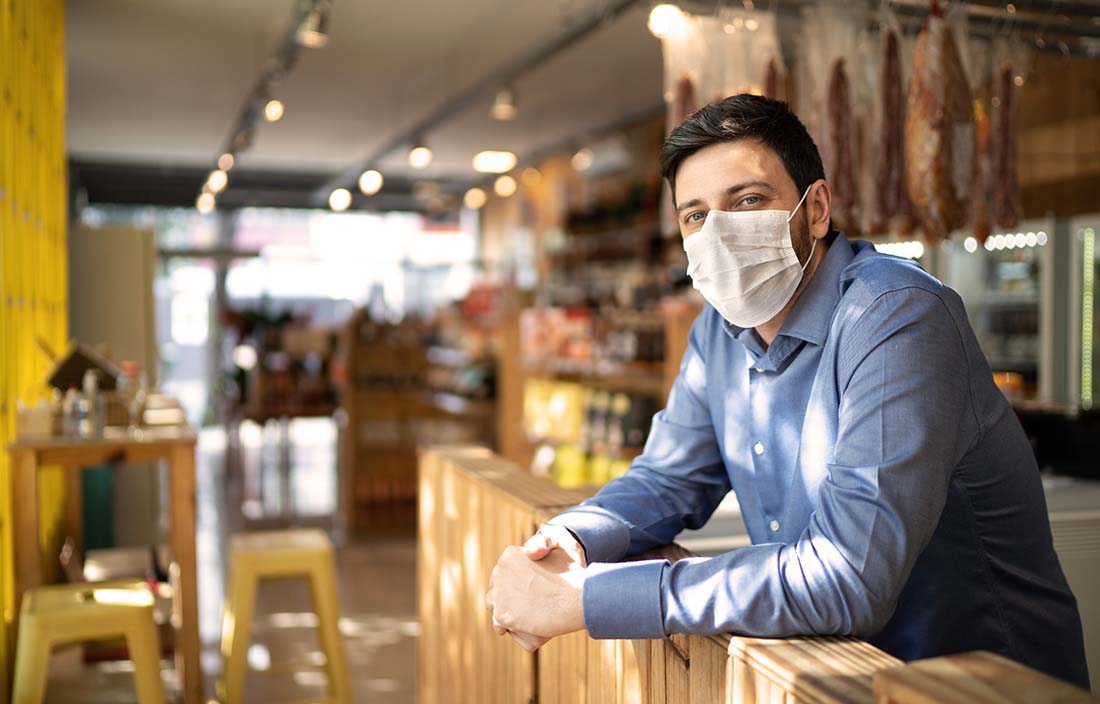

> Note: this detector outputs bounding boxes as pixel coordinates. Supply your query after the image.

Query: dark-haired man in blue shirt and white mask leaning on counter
[486,95,1088,688]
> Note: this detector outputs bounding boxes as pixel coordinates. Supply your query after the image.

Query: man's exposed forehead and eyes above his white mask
[673,140,811,262]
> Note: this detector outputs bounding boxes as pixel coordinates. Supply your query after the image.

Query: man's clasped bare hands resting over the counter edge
[485,524,587,652]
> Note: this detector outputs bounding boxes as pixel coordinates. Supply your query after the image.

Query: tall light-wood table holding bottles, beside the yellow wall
[8,427,202,704]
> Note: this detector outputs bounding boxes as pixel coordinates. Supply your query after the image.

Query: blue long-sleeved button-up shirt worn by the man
[553,234,1088,686]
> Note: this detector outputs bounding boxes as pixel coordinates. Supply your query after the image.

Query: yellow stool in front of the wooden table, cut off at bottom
[12,581,164,704]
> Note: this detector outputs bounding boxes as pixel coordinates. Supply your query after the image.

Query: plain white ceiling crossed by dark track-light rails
[67,0,661,185]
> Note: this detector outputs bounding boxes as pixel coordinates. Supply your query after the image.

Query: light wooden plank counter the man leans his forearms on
[417,447,1093,704]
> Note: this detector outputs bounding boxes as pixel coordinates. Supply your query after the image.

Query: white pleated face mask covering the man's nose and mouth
[684,188,817,328]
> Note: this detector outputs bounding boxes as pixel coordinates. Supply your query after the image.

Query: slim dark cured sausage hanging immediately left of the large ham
[870,30,909,232]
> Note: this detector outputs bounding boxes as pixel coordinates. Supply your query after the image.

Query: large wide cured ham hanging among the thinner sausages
[905,0,975,244]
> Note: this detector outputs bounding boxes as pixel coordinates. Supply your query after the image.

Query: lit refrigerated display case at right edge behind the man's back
[928,213,1100,479]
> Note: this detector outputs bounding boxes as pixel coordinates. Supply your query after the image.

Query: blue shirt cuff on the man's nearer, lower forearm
[582,560,669,639]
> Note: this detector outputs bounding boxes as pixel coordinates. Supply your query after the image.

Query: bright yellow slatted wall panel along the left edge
[0,0,68,702]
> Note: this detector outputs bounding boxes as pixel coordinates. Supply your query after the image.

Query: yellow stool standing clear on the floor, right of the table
[219,529,351,704]
